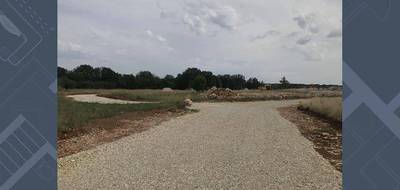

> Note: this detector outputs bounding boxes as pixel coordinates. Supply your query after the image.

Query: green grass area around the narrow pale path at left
[58,90,200,134]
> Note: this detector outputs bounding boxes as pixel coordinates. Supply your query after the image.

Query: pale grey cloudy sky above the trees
[58,0,342,84]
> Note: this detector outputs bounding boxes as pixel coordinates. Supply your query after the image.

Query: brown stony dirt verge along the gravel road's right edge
[278,106,342,172]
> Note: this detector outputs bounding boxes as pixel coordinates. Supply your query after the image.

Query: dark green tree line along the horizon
[57,65,342,91]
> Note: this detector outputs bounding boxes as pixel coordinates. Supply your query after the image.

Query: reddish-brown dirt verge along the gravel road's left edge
[57,109,188,158]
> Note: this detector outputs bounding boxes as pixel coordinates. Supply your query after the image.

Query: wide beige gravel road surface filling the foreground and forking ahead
[58,101,342,190]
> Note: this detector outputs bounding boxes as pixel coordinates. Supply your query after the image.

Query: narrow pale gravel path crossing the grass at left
[67,94,158,104]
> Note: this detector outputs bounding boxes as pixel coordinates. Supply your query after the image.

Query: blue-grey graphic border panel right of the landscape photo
[343,0,400,190]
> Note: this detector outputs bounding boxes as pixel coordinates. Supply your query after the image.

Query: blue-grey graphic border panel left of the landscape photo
[0,0,57,190]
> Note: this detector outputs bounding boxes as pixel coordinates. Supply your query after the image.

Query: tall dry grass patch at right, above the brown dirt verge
[299,97,342,121]
